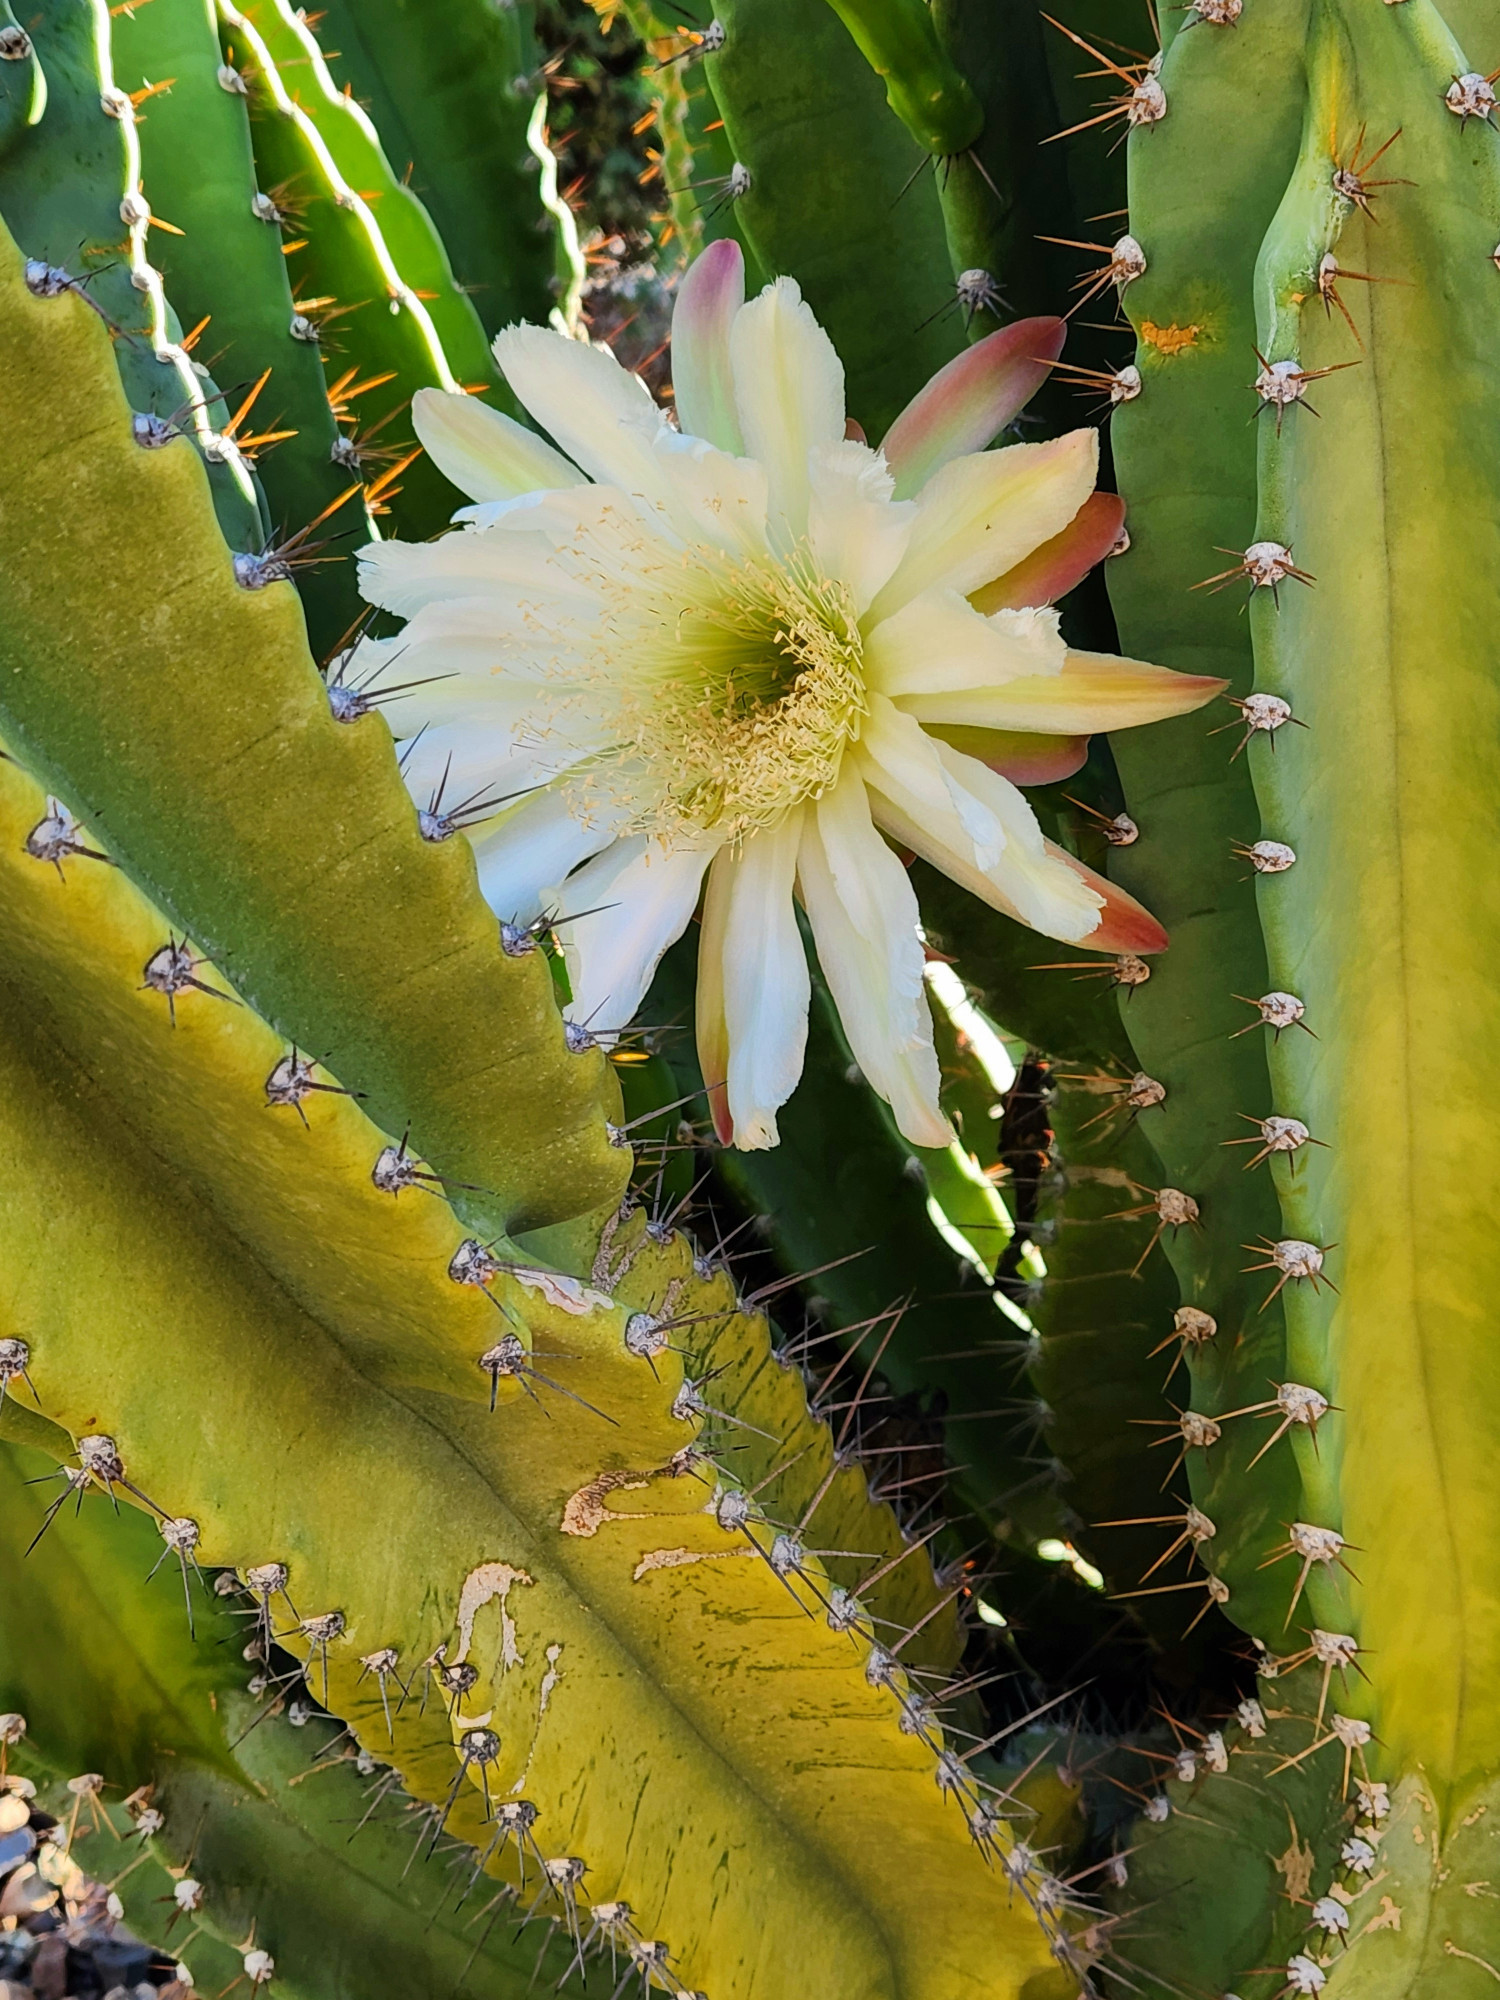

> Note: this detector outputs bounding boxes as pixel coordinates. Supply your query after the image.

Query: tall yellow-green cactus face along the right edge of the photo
[1250,0,1500,1828]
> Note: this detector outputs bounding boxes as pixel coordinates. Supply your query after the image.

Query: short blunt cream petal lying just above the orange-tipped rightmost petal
[864,590,1068,698]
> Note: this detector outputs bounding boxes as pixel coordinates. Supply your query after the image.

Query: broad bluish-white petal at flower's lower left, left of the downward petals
[548,834,712,1034]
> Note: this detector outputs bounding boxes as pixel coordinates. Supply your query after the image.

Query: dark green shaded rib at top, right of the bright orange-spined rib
[304,0,556,340]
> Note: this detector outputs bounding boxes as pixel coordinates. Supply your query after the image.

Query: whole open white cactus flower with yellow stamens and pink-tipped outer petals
[354,242,1220,1148]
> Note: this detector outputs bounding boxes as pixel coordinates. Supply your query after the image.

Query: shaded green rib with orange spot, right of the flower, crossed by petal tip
[1108,0,1306,1636]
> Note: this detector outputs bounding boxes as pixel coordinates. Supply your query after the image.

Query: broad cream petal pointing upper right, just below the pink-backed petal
[870,430,1098,620]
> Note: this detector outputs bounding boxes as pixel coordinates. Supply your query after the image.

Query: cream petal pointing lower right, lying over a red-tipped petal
[866,744,1102,948]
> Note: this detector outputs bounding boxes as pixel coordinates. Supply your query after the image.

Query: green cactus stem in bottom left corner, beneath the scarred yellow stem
[0,1446,600,2000]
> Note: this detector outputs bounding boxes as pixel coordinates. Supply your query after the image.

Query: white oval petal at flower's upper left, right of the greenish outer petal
[494,326,666,494]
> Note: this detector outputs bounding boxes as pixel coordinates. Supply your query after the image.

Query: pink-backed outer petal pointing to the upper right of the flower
[882,318,1068,500]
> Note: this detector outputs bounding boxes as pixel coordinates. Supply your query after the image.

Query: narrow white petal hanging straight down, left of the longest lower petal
[716,808,812,1152]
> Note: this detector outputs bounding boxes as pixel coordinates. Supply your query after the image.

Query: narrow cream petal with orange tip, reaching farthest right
[902,652,1226,734]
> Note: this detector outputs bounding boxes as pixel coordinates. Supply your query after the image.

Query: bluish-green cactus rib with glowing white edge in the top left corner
[0,0,266,550]
